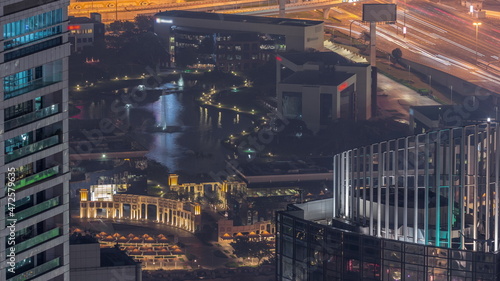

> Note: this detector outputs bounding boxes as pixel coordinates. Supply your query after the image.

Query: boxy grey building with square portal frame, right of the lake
[276,52,372,133]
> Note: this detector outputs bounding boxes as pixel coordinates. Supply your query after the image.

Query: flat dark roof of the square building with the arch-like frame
[282,70,355,86]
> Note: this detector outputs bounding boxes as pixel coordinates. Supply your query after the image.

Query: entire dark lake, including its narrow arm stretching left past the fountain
[73,83,252,174]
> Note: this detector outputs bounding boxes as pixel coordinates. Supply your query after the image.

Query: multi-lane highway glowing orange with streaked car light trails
[327,0,500,94]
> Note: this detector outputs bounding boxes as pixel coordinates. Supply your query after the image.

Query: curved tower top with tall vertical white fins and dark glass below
[277,123,500,281]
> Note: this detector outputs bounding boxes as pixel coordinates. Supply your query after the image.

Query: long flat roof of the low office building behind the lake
[155,10,323,26]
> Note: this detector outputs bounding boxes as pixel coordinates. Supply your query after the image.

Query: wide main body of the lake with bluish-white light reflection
[145,93,252,173]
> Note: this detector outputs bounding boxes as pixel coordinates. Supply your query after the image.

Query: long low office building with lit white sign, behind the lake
[154,10,323,71]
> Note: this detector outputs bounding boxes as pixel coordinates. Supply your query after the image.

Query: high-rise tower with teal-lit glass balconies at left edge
[0,0,70,281]
